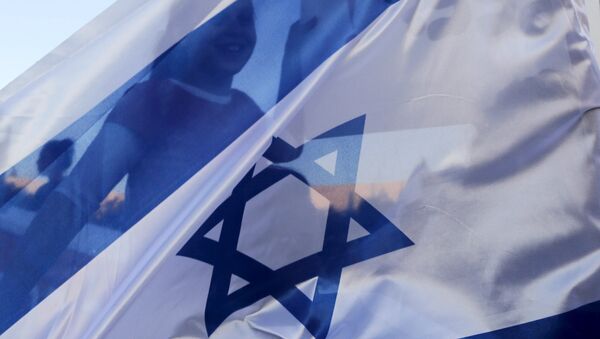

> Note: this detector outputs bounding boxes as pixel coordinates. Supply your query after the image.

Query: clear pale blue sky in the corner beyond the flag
[0,0,115,89]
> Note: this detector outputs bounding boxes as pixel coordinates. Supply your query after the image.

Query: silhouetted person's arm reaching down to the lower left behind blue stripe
[0,122,142,311]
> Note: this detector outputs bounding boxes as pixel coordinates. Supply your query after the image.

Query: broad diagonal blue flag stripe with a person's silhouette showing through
[0,1,404,336]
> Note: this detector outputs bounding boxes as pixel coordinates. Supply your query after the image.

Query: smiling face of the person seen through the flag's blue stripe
[191,0,256,75]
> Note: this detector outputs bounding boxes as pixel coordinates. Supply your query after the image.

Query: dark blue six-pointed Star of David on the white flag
[178,116,413,338]
